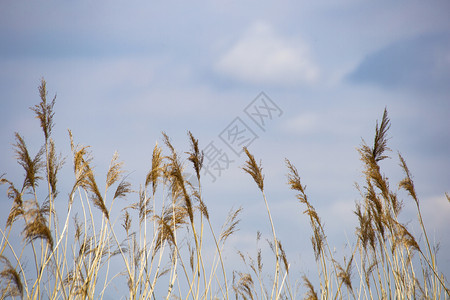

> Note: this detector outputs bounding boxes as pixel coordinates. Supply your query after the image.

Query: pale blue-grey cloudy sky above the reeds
[0,0,450,296]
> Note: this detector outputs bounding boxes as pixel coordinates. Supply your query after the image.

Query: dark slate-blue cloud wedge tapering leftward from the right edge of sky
[347,34,450,92]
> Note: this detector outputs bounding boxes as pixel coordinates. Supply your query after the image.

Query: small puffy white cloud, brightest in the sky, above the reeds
[216,22,319,85]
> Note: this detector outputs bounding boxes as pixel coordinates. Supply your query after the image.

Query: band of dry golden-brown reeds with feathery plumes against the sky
[0,79,450,299]
